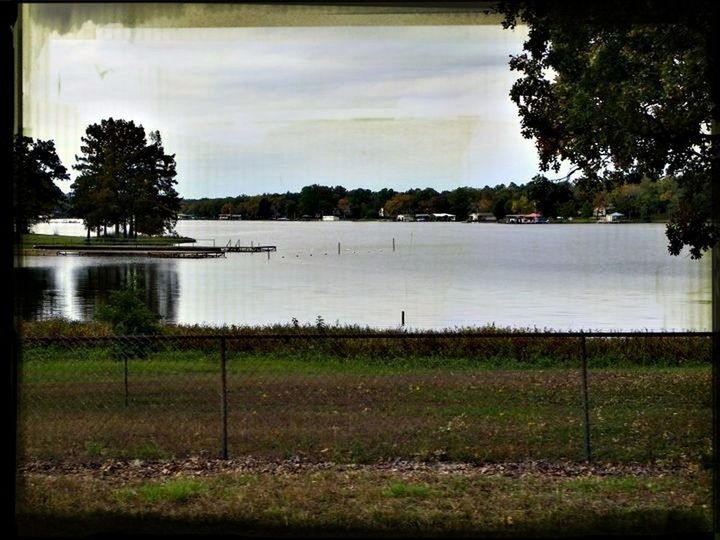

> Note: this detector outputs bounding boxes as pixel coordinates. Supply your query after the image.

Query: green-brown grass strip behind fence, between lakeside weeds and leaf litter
[19,345,712,463]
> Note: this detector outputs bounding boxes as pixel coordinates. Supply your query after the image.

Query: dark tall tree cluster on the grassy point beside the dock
[71,118,180,237]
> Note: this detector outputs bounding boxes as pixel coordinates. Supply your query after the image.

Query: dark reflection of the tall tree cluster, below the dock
[73,262,179,322]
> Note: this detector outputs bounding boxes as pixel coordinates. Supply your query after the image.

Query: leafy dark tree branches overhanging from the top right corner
[500,0,720,258]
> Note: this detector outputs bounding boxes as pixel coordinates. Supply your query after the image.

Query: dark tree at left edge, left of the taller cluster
[12,135,69,233]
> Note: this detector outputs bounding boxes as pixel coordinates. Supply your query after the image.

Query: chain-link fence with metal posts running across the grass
[18,332,712,462]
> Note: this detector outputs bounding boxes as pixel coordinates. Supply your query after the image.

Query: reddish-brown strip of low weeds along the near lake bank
[21,319,712,369]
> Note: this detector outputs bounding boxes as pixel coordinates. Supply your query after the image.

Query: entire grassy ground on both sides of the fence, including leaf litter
[16,334,712,537]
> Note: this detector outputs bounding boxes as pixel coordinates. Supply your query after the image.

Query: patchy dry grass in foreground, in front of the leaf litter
[17,468,712,537]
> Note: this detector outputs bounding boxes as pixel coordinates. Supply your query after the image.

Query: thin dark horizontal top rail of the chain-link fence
[21,331,714,343]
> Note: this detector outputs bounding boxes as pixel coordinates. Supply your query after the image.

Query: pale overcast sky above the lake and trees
[25,21,568,198]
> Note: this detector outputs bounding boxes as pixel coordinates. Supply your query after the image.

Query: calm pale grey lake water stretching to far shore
[19,220,711,331]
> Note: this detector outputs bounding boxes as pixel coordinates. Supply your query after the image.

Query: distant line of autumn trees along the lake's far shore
[180,176,680,221]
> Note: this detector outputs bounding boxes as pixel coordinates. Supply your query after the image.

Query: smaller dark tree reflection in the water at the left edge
[16,267,62,321]
